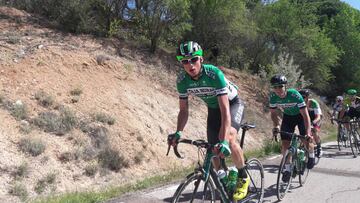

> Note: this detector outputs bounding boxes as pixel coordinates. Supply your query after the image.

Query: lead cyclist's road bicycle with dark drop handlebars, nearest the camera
[167,124,264,203]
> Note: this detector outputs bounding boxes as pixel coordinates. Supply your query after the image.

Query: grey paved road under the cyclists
[107,142,360,203]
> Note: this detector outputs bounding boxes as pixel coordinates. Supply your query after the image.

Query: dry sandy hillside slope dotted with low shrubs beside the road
[0,7,334,202]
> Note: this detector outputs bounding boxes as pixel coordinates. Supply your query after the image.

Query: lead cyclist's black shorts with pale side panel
[206,97,245,144]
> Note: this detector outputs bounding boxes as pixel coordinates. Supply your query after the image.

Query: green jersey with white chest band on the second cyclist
[270,89,306,116]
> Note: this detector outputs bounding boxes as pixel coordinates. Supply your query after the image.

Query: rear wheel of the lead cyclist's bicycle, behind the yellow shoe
[242,159,264,203]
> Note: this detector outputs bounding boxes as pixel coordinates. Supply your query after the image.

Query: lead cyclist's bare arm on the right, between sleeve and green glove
[217,94,231,141]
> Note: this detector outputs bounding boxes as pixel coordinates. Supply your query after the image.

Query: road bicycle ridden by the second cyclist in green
[276,131,310,201]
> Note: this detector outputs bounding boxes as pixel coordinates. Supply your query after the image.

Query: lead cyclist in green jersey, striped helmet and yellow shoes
[168,41,250,200]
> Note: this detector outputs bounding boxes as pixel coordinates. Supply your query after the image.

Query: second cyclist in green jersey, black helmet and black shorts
[270,74,315,182]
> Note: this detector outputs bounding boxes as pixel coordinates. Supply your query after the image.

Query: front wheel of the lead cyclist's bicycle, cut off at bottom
[171,173,216,203]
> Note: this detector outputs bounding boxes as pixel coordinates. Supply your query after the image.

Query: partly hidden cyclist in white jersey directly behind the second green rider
[299,89,322,157]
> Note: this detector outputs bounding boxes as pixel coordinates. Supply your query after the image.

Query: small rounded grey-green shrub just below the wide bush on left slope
[19,138,45,156]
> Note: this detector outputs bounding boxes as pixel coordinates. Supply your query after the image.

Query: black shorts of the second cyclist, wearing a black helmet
[280,114,306,141]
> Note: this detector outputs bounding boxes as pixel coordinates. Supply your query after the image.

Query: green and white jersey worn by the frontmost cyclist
[177,64,238,108]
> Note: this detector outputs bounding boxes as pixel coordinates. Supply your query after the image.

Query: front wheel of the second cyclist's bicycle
[276,150,294,201]
